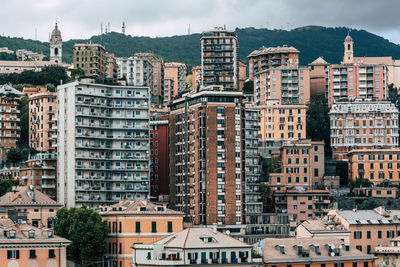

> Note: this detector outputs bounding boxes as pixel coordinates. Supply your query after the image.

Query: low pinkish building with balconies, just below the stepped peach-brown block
[273,187,331,223]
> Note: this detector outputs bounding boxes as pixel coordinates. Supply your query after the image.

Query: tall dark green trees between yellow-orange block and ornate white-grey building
[307,95,331,155]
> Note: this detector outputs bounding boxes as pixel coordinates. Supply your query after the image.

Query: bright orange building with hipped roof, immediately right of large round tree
[100,200,183,267]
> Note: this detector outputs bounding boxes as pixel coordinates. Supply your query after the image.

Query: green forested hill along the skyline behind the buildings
[0,26,400,65]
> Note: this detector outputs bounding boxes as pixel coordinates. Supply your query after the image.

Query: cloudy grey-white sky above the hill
[0,0,400,43]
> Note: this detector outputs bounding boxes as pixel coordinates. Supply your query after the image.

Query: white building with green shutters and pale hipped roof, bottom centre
[133,227,261,267]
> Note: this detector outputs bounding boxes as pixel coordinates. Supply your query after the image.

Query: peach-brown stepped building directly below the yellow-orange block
[267,139,325,190]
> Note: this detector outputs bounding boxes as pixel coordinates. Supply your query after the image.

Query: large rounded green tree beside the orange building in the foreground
[54,207,108,266]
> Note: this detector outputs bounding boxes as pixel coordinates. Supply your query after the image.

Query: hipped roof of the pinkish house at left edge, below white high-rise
[0,186,62,207]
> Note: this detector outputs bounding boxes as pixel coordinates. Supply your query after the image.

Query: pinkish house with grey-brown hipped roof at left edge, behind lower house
[0,186,62,228]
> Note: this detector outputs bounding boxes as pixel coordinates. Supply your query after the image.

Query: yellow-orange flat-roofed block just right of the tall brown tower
[255,100,307,159]
